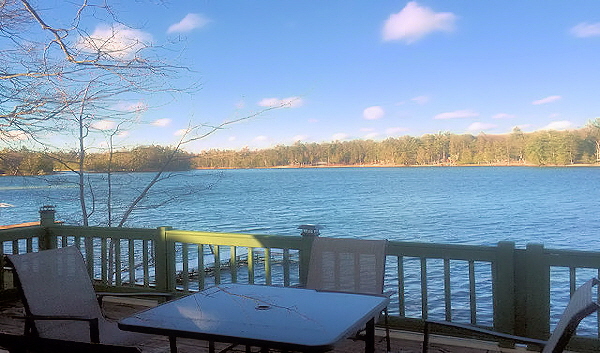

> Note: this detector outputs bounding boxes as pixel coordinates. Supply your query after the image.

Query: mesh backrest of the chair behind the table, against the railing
[306,237,387,294]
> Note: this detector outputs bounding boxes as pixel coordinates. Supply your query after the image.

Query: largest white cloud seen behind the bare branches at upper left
[76,24,152,60]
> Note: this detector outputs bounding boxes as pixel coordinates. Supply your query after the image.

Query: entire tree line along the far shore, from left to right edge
[0,119,600,175]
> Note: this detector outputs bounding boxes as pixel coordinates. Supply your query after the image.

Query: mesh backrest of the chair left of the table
[7,246,102,337]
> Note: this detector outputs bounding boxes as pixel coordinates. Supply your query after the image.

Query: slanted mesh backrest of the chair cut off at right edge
[542,278,599,353]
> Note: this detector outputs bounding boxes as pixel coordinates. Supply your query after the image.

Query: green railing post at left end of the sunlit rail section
[154,227,175,292]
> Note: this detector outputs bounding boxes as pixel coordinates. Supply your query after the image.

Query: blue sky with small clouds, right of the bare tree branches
[54,0,600,152]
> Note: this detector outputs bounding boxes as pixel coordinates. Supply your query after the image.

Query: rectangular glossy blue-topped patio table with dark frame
[119,284,389,353]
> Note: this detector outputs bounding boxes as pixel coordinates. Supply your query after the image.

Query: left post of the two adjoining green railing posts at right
[492,241,516,334]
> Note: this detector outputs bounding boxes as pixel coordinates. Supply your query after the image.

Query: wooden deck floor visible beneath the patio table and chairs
[0,298,527,353]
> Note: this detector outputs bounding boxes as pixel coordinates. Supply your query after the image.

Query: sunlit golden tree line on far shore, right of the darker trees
[193,120,600,168]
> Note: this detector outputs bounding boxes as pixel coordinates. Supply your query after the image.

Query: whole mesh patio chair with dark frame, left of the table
[6,246,170,346]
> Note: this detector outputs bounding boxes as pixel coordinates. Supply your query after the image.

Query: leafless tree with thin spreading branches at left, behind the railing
[0,0,291,226]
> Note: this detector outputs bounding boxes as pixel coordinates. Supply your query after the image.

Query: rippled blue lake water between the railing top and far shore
[0,167,600,251]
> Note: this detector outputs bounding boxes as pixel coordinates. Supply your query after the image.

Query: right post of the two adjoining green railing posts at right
[515,244,550,340]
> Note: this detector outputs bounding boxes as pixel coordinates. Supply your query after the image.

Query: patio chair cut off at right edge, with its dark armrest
[423,278,600,353]
